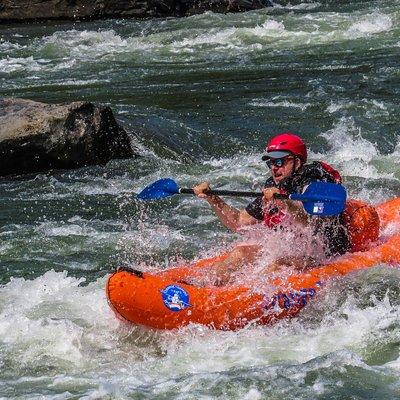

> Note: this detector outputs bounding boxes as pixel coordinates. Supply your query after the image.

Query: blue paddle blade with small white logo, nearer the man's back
[290,182,346,217]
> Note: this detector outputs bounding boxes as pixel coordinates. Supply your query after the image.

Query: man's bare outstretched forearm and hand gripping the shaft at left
[193,182,259,232]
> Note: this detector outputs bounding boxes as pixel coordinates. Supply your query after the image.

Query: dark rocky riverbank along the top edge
[0,0,271,22]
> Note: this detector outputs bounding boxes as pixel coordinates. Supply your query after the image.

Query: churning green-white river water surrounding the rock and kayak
[0,0,400,400]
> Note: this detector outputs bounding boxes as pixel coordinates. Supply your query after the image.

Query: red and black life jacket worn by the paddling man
[263,161,342,229]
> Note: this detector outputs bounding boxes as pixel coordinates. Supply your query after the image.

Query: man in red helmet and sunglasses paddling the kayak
[193,133,351,264]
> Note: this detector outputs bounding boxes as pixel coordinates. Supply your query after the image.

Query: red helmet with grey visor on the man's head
[264,132,307,162]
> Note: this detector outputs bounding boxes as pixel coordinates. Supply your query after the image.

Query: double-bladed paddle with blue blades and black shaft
[137,178,346,217]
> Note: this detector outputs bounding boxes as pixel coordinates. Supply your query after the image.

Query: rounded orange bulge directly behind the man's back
[342,200,380,252]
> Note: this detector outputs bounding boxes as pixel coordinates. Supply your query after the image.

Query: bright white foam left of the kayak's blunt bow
[0,271,117,367]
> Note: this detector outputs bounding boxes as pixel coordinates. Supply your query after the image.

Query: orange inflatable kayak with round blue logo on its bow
[106,198,400,330]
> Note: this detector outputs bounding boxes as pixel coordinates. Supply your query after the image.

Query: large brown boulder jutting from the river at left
[0,99,134,176]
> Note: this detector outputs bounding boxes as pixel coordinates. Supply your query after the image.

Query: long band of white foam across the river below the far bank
[0,8,394,77]
